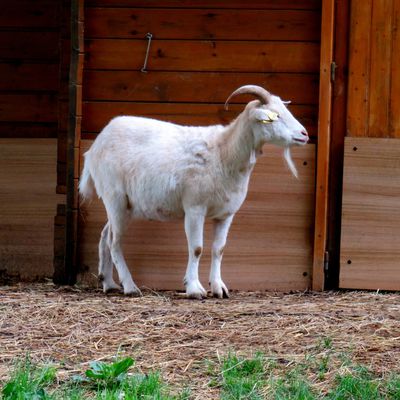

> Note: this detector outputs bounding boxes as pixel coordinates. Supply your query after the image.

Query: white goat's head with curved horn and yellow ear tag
[225,85,308,147]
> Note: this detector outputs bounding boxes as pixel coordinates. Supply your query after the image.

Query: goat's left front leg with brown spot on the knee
[183,208,207,299]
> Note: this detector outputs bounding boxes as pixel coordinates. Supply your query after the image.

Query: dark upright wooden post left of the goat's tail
[53,0,84,284]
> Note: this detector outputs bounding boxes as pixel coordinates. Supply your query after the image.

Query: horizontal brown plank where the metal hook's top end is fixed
[85,8,321,42]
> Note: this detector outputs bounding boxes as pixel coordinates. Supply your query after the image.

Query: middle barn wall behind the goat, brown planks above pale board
[79,0,321,290]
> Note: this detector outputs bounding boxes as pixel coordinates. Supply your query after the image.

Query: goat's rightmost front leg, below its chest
[210,215,233,299]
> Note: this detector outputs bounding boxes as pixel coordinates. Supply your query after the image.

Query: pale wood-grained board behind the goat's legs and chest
[79,141,315,290]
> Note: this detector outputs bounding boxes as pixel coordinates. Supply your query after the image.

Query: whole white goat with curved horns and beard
[79,85,308,299]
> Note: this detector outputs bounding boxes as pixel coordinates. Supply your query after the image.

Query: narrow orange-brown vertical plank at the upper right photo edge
[389,0,400,138]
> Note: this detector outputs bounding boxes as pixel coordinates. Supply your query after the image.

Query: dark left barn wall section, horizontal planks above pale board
[0,0,61,281]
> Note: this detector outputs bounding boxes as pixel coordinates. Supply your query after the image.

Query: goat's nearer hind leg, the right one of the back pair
[104,196,141,296]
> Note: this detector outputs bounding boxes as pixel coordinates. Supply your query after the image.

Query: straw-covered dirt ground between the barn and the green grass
[0,283,400,398]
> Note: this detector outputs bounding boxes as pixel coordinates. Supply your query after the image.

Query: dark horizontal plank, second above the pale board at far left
[0,93,57,122]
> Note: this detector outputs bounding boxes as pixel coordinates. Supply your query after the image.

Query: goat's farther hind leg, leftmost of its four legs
[99,221,121,293]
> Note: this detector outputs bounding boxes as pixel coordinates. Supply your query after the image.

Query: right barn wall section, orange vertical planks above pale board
[340,0,400,290]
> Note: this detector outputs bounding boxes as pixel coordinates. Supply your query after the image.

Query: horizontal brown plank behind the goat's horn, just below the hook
[83,70,319,104]
